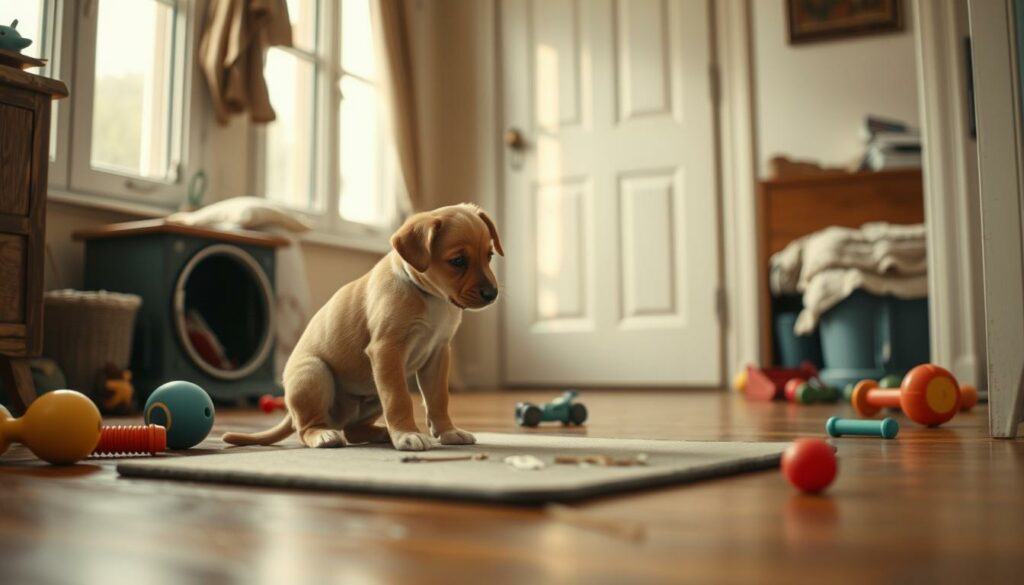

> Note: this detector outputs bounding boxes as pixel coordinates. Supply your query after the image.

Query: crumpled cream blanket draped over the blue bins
[769,222,928,335]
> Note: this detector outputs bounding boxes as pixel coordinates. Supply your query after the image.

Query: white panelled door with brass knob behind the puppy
[501,0,722,385]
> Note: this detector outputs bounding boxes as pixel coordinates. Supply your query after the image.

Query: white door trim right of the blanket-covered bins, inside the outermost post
[912,0,985,389]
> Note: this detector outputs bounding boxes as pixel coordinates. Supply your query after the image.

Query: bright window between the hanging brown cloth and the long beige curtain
[261,0,399,237]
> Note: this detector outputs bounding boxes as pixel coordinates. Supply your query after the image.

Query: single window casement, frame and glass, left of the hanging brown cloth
[70,0,191,205]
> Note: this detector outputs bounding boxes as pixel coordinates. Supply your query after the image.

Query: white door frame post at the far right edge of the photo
[968,0,1024,437]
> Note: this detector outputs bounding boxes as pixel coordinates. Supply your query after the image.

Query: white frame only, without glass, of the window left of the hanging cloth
[64,0,202,210]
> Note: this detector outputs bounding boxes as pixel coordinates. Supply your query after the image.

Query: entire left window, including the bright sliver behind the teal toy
[0,0,190,207]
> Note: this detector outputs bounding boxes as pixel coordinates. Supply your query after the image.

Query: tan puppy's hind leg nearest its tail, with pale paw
[285,357,345,449]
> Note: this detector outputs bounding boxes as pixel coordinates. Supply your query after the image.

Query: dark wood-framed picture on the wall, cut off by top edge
[785,0,903,44]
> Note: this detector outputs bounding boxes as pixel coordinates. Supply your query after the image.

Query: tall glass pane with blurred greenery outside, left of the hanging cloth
[91,0,174,179]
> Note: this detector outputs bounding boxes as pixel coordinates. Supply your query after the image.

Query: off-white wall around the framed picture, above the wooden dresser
[752,0,919,177]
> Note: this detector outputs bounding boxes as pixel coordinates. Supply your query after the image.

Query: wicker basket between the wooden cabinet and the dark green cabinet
[43,289,142,395]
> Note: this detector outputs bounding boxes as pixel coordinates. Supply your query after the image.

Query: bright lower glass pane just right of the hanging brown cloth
[263,49,322,210]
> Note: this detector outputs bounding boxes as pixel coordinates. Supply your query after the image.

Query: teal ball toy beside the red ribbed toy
[145,380,213,449]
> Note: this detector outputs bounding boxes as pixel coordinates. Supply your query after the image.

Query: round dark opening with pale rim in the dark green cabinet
[174,244,273,380]
